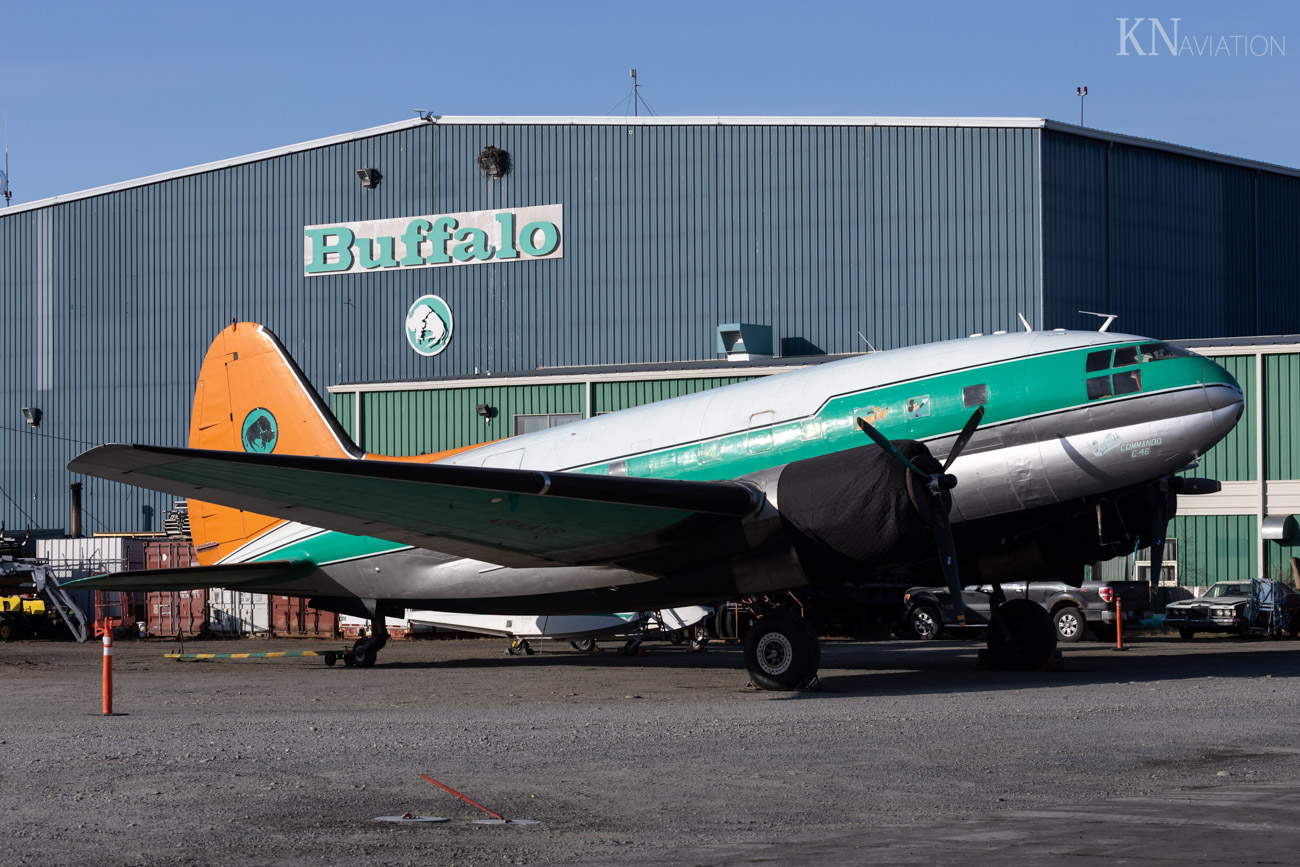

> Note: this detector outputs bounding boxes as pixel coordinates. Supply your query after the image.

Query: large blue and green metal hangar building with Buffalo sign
[0,116,1300,584]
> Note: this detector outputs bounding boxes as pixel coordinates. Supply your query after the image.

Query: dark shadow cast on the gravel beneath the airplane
[366,638,1300,697]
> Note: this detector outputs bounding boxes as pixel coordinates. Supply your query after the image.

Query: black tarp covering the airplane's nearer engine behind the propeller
[777,439,939,581]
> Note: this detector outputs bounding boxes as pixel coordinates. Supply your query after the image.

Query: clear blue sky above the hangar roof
[0,0,1300,203]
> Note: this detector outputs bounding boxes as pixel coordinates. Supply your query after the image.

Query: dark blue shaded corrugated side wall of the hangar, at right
[1043,131,1300,338]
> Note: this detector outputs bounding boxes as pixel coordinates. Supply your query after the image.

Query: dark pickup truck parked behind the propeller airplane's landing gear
[904,581,1151,641]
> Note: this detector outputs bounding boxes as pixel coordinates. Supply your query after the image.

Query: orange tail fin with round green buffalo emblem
[190,322,361,565]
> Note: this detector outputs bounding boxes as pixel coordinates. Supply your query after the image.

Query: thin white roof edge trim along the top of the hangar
[0,114,1300,217]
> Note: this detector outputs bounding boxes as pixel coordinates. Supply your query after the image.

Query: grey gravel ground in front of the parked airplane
[0,637,1300,866]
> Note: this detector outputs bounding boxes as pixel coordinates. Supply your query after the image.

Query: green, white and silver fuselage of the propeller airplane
[225,331,1243,608]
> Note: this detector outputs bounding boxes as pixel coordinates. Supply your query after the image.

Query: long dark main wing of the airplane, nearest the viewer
[68,445,761,567]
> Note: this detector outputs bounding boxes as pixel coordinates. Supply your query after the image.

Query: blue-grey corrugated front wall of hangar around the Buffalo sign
[0,123,1040,530]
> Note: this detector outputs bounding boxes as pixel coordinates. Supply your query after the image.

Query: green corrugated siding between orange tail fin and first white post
[358,383,585,455]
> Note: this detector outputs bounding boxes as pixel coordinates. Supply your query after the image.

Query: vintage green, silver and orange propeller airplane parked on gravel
[69,322,1243,689]
